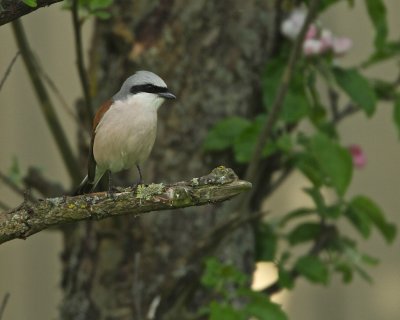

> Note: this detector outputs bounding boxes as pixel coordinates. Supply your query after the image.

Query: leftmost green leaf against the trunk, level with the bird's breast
[203,117,251,151]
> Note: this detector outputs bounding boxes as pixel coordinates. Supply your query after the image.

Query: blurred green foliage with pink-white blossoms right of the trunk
[203,0,400,319]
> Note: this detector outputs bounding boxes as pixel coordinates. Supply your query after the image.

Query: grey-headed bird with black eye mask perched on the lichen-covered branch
[76,71,175,194]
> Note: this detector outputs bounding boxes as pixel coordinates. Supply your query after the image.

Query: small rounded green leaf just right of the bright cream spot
[295,256,329,284]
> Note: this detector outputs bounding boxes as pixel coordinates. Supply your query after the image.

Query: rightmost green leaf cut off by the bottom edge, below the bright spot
[242,292,287,320]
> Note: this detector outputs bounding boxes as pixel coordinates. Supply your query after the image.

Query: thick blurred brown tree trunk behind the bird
[61,0,275,320]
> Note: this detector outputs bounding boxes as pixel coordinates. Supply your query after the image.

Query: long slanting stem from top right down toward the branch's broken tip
[245,0,319,182]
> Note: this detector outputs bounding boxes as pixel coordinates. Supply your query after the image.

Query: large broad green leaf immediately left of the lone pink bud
[309,133,353,196]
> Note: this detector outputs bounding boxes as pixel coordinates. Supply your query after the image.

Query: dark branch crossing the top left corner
[0,0,62,26]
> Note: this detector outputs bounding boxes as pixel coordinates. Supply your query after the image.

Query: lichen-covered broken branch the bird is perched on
[0,167,251,244]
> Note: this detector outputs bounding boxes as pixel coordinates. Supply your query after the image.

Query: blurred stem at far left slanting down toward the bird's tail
[12,20,80,184]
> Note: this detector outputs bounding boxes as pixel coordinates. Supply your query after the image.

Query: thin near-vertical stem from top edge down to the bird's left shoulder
[71,0,93,127]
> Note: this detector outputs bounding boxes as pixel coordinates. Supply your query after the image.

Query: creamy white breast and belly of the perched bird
[93,94,162,175]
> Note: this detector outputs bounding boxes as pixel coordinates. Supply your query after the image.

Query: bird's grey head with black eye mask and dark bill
[113,71,176,101]
